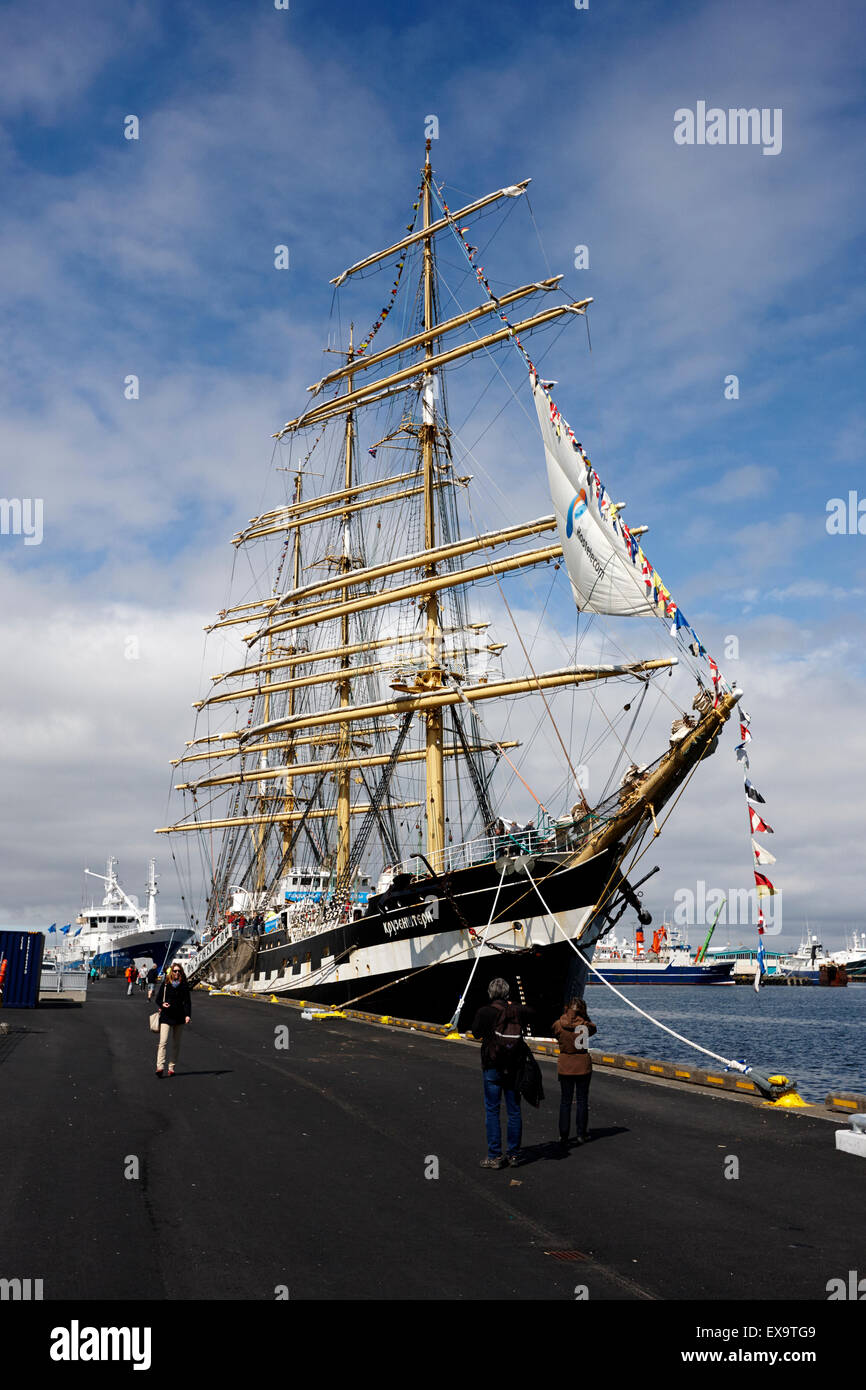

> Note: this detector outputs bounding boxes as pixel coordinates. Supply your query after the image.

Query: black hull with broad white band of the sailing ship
[249,851,617,1031]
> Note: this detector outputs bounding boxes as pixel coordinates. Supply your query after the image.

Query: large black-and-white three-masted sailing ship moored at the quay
[160,140,740,1022]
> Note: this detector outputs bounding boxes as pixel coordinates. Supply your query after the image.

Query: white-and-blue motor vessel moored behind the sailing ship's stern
[64,858,195,970]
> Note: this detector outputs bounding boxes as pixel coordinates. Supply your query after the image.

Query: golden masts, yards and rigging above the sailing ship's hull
[155,142,733,995]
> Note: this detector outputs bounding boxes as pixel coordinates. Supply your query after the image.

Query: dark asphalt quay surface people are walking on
[0,980,866,1322]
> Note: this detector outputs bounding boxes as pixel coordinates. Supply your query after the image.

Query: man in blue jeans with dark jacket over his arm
[471,980,535,1168]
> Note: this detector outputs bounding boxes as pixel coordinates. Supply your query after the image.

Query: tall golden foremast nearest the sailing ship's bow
[421,140,445,863]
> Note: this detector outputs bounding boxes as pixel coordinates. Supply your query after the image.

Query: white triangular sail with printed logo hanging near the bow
[532,378,659,617]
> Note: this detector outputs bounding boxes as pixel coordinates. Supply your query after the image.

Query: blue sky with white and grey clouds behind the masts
[0,0,866,945]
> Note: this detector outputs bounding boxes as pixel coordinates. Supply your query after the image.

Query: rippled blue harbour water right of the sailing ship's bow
[578,984,866,1102]
